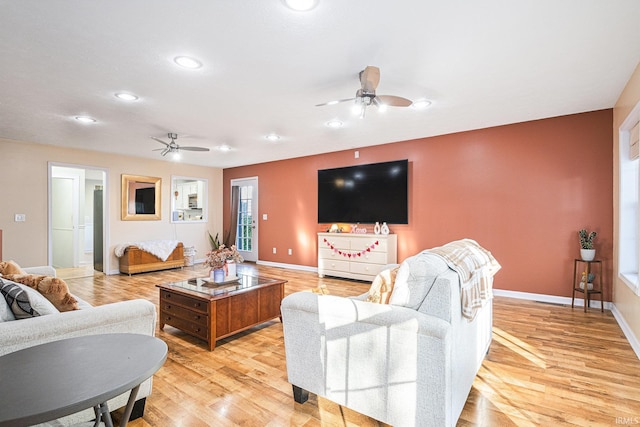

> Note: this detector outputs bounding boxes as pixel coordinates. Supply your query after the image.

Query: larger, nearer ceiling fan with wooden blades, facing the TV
[316,65,412,118]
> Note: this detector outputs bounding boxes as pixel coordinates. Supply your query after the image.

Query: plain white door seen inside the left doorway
[51,178,79,268]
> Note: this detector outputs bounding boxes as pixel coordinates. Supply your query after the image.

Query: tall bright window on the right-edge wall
[618,103,640,295]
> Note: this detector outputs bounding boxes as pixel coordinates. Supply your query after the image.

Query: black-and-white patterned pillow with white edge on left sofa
[0,279,59,320]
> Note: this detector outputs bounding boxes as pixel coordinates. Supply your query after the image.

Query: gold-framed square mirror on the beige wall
[122,174,162,221]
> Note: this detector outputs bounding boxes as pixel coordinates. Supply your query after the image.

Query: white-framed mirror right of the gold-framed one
[170,176,208,223]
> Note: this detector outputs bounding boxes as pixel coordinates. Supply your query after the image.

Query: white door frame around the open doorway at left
[47,162,111,274]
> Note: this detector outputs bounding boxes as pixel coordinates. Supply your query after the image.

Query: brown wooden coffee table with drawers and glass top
[156,274,286,350]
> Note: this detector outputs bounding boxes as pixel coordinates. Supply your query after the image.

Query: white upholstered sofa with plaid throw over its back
[281,242,500,427]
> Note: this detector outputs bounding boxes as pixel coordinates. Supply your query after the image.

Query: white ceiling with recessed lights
[0,0,640,167]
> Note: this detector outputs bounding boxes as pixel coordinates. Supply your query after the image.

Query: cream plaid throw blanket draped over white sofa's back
[425,239,501,320]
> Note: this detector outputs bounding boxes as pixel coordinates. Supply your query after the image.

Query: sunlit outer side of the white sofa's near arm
[282,292,451,425]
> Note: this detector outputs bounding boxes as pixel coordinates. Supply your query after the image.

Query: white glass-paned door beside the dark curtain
[231,177,258,262]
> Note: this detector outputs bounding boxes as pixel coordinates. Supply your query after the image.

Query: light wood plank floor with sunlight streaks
[66,263,640,427]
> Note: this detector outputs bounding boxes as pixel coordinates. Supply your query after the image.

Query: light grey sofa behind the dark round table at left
[0,266,156,425]
